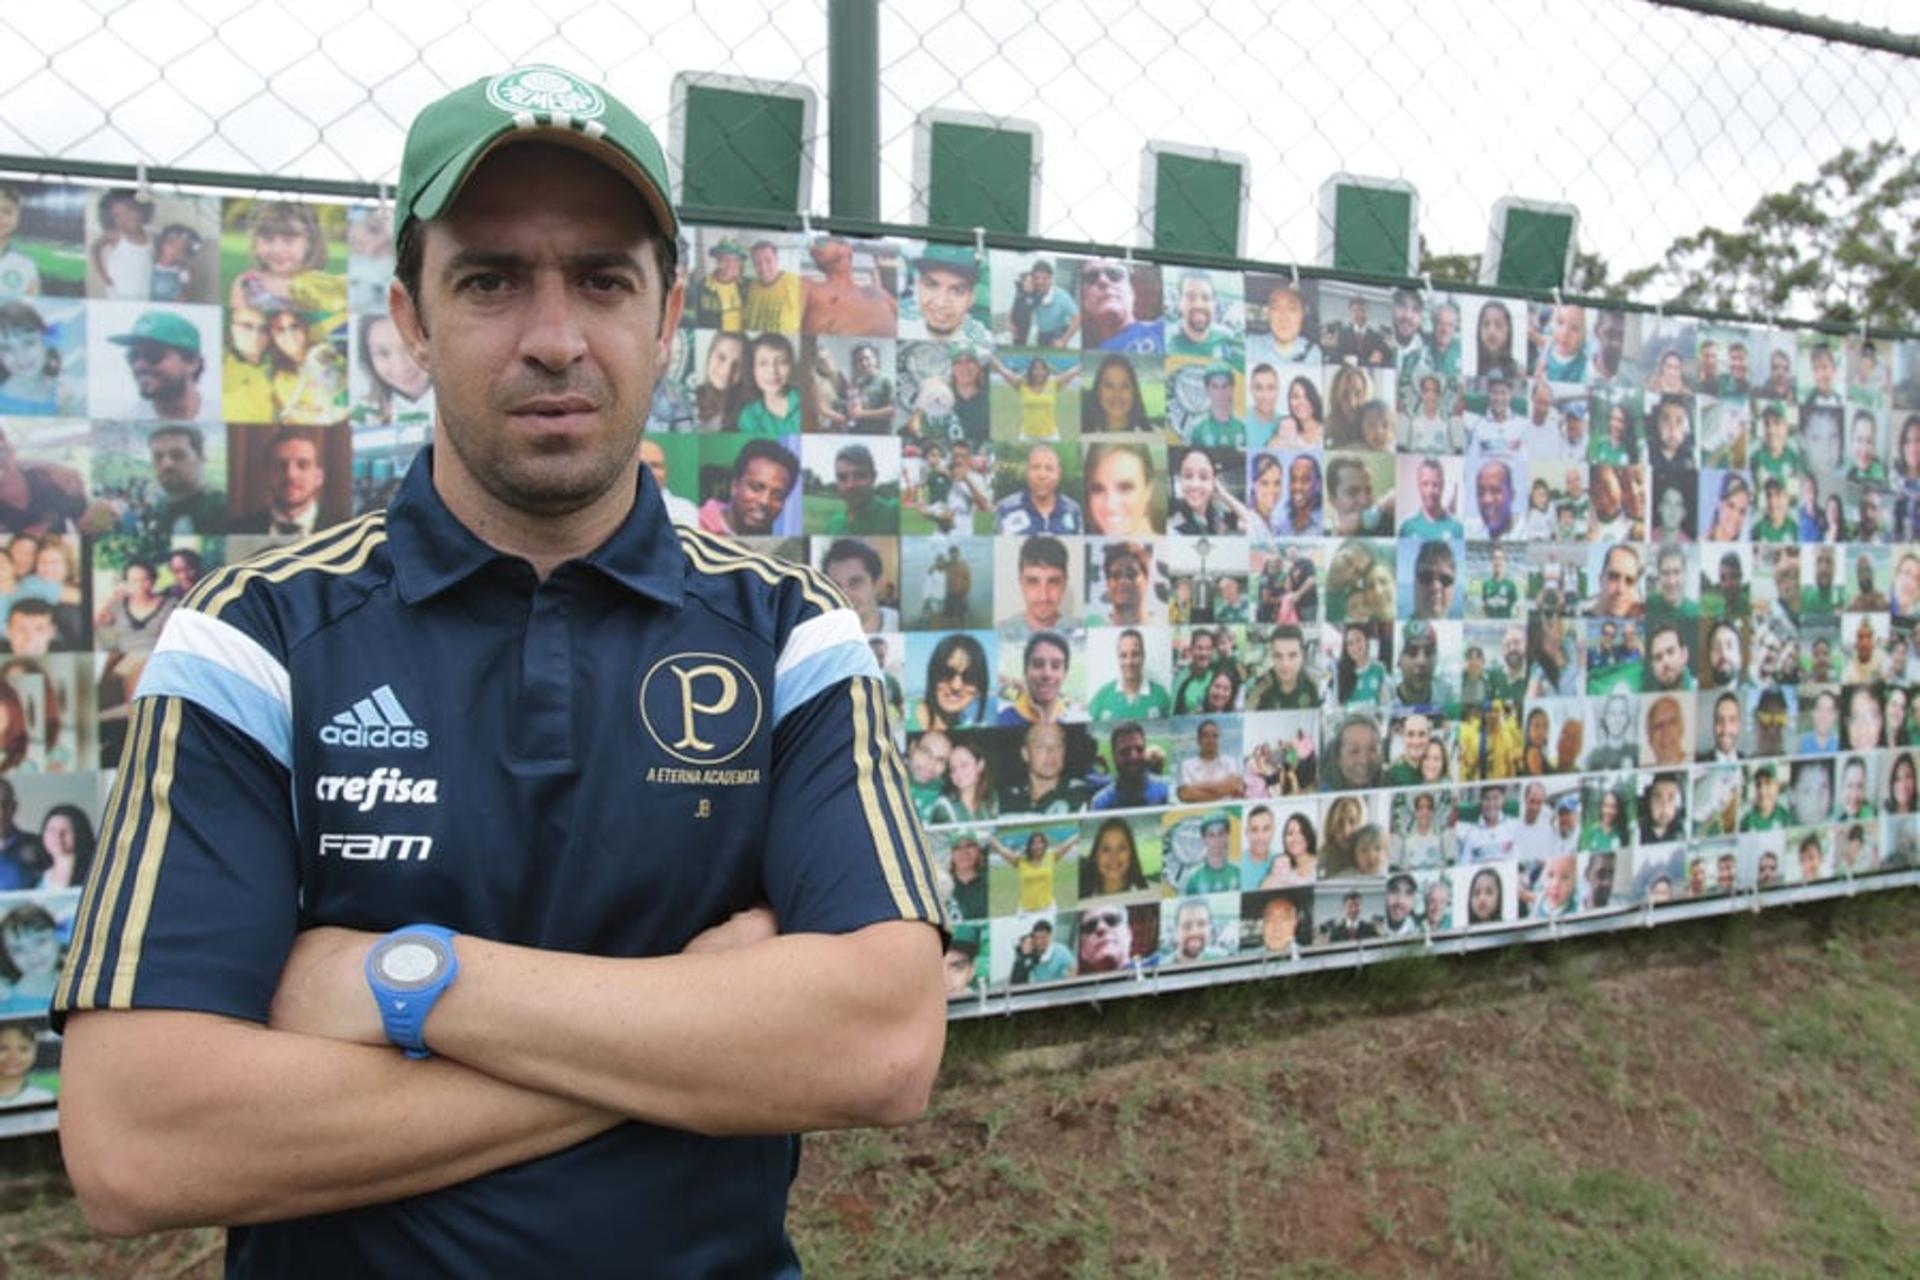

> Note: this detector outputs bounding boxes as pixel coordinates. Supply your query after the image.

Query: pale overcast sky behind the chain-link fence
[0,0,1920,280]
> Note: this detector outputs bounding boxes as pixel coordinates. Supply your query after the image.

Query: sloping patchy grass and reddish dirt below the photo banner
[793,894,1920,1278]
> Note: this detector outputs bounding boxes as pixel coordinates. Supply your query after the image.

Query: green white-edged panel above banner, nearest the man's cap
[680,84,806,213]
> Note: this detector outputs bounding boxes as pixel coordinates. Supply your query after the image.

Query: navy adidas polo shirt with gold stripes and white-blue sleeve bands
[54,451,941,1276]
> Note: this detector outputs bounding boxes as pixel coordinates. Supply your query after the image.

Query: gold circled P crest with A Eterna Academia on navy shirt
[639,652,766,787]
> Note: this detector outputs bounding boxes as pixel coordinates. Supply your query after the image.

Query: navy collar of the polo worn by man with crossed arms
[386,445,687,608]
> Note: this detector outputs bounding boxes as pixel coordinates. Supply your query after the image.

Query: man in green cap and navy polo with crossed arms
[54,67,945,1276]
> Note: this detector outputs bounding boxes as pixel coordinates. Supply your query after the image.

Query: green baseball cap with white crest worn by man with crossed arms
[396,63,680,245]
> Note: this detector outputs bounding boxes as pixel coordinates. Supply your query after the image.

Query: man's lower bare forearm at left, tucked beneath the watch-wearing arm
[60,1009,620,1234]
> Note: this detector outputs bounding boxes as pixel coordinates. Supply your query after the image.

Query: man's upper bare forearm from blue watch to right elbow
[426,921,947,1134]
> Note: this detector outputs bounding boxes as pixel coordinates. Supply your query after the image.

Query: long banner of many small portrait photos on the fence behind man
[0,178,1920,1113]
